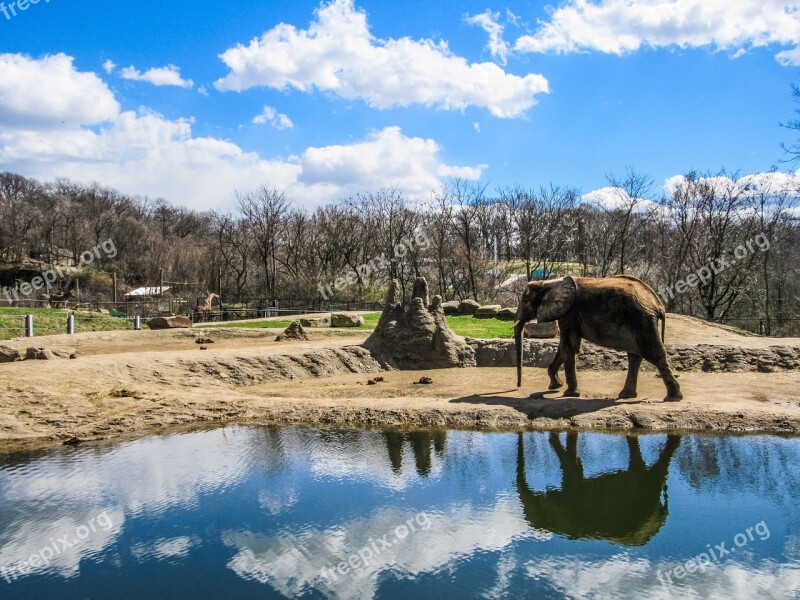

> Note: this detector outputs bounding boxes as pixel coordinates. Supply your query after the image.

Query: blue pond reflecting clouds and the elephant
[0,426,800,600]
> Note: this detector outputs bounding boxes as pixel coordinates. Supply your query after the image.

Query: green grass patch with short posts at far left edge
[0,308,133,340]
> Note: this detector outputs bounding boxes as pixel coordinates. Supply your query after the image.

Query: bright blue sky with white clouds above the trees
[0,0,800,208]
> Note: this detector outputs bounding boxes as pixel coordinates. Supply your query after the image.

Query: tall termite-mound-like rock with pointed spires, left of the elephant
[364,278,475,369]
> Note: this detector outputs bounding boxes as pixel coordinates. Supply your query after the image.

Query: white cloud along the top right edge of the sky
[515,0,800,64]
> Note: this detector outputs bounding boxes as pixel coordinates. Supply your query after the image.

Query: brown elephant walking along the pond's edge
[514,275,683,402]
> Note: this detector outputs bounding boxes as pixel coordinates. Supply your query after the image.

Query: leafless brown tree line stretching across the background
[0,171,800,335]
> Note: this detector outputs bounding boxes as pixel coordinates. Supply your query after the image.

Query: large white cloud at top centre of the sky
[215,0,548,118]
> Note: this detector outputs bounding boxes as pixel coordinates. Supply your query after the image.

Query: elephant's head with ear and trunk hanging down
[514,277,578,387]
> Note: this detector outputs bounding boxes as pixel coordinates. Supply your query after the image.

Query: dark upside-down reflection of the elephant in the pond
[517,432,680,546]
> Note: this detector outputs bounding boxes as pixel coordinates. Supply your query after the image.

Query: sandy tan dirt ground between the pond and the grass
[0,315,800,451]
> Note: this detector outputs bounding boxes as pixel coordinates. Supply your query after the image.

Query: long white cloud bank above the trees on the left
[0,55,484,209]
